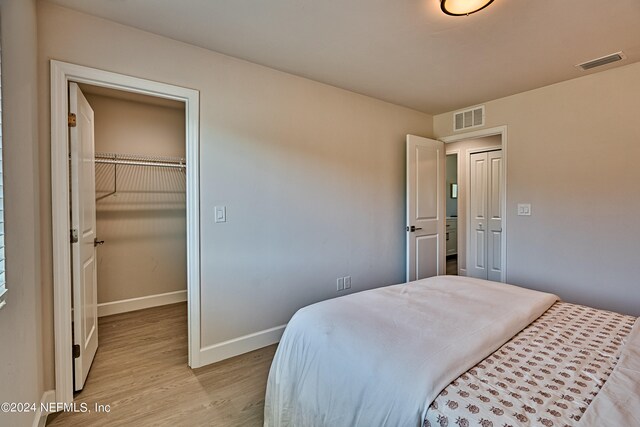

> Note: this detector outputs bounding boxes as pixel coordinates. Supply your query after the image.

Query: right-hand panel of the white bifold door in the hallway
[486,150,502,282]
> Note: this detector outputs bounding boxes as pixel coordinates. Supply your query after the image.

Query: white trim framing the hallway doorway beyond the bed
[439,125,508,283]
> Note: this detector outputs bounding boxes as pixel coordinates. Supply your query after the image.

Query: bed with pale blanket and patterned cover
[264,276,640,427]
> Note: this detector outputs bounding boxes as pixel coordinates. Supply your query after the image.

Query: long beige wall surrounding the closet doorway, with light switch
[38,2,433,386]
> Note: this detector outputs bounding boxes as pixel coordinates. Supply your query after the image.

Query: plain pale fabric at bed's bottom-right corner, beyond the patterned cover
[578,319,640,427]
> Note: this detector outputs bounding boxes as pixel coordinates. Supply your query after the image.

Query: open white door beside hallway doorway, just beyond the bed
[406,135,446,282]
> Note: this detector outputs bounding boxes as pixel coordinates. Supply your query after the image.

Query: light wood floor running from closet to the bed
[47,303,276,427]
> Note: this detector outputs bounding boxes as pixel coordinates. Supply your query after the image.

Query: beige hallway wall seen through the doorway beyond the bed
[445,135,502,275]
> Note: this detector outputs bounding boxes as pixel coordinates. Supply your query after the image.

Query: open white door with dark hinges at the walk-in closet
[69,83,98,391]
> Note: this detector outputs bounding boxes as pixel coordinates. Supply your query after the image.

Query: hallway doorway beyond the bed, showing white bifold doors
[441,126,507,282]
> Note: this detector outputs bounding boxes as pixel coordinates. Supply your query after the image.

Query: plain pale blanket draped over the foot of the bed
[264,276,557,427]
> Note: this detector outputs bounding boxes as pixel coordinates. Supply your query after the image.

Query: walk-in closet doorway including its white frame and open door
[51,61,200,403]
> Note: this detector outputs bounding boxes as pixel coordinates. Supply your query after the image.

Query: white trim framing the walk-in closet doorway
[51,60,201,403]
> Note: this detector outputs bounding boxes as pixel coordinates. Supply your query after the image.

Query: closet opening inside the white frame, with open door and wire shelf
[69,82,187,392]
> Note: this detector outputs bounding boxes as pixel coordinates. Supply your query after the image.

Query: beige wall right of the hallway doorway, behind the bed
[434,63,640,316]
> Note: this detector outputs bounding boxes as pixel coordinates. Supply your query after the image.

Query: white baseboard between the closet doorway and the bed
[194,325,287,368]
